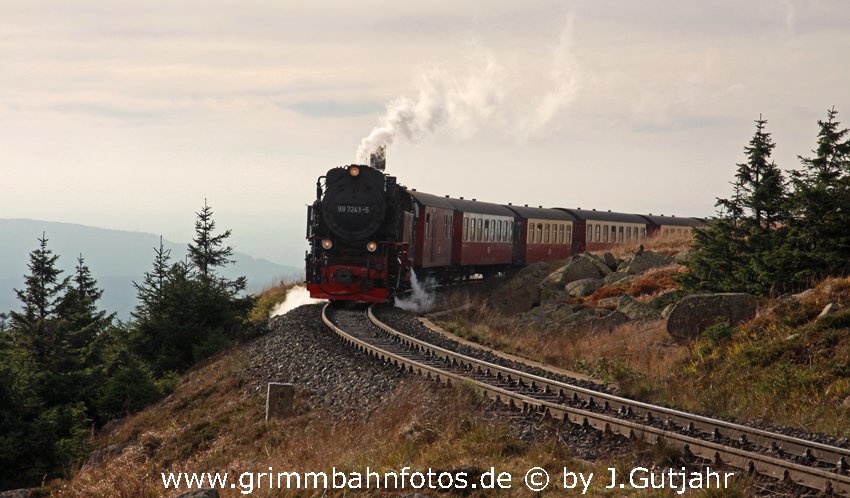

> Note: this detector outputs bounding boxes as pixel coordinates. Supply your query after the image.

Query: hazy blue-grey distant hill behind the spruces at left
[0,219,304,319]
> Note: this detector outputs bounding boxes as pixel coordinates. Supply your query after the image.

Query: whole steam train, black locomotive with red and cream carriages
[305,155,707,303]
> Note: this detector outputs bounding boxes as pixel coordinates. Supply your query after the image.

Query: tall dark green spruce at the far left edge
[0,235,91,485]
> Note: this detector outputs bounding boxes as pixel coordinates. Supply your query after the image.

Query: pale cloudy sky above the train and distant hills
[0,0,850,266]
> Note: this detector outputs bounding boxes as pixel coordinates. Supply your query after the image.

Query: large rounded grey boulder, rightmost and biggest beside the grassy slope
[667,293,757,341]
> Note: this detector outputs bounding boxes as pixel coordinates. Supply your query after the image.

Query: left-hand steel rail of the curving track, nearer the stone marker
[322,304,850,496]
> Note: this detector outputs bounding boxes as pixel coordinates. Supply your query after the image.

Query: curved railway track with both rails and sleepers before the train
[322,304,850,496]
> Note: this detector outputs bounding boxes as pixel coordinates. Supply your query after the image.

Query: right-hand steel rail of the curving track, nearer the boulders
[368,307,850,468]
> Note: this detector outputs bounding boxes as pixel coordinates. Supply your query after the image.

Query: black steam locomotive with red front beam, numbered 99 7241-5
[306,150,412,302]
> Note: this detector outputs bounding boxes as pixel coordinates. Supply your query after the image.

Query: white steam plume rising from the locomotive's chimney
[357,17,580,164]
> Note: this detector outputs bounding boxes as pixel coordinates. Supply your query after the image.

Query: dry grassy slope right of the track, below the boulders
[440,243,850,437]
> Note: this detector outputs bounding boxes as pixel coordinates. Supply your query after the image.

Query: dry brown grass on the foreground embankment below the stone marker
[51,342,652,498]
